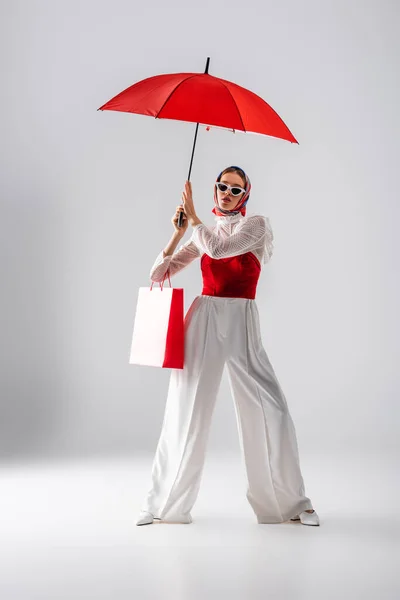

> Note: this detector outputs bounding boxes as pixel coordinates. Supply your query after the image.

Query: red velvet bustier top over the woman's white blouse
[200,252,261,300]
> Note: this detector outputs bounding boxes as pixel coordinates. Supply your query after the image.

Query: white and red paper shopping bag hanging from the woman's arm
[129,271,184,369]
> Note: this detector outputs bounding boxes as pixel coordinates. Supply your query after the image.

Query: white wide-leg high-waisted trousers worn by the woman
[142,295,313,523]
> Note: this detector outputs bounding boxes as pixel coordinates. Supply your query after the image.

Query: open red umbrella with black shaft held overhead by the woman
[98,58,298,226]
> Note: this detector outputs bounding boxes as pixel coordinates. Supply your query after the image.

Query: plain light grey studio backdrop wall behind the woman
[0,0,400,460]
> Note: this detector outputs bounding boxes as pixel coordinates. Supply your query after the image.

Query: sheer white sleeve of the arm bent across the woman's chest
[191,215,272,262]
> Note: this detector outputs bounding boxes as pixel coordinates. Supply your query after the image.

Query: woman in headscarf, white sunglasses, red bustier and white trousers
[137,166,319,525]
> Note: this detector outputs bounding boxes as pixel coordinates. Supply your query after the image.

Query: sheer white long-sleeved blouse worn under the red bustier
[150,213,274,282]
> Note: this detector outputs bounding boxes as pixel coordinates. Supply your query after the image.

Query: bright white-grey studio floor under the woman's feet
[0,454,400,600]
